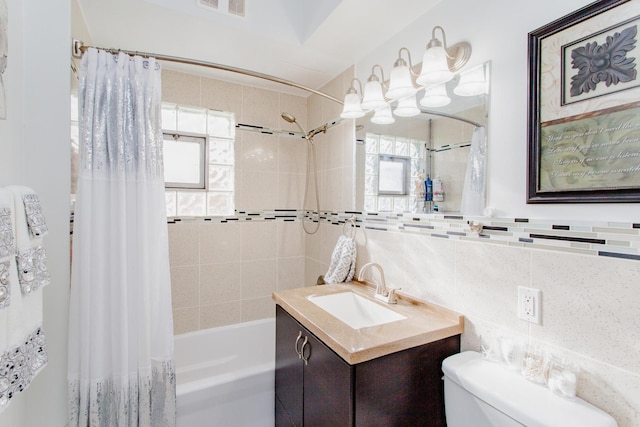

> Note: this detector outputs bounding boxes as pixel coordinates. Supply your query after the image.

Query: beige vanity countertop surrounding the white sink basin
[273,282,464,365]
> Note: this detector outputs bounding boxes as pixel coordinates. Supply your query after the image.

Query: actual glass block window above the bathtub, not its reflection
[162,103,236,217]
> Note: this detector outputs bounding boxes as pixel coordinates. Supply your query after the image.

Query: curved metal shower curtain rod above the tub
[71,39,343,105]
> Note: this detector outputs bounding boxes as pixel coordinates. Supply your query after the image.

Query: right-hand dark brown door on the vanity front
[304,331,353,427]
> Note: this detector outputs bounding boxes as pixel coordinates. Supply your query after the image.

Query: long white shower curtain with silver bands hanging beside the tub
[68,49,175,427]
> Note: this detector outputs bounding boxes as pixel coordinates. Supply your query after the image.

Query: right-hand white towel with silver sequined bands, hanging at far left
[6,186,50,295]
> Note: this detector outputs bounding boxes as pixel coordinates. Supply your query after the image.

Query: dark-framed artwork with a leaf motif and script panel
[527,0,640,203]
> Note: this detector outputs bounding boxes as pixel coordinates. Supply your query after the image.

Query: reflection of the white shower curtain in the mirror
[460,126,487,215]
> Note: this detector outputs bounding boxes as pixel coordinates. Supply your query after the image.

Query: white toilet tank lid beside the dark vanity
[442,351,618,427]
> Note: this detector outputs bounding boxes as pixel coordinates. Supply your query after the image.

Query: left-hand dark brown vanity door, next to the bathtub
[275,306,307,427]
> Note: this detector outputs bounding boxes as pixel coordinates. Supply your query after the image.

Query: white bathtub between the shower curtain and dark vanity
[174,319,275,427]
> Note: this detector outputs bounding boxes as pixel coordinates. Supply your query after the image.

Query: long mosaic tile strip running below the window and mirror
[169,209,640,261]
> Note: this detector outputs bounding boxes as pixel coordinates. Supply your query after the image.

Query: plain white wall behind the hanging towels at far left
[0,0,70,427]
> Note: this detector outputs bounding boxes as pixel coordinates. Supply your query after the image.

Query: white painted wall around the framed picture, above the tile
[356,0,638,221]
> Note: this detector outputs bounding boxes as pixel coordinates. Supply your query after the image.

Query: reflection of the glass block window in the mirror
[364,133,425,212]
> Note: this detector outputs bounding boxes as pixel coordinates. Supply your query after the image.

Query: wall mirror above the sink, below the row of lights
[355,62,489,213]
